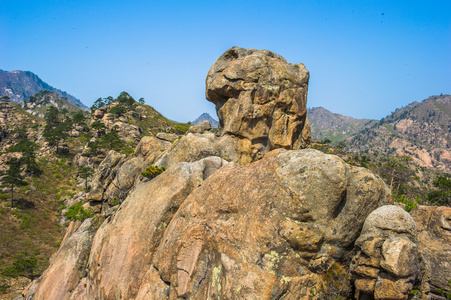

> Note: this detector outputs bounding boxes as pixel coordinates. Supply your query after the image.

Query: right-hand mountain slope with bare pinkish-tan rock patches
[346,95,451,173]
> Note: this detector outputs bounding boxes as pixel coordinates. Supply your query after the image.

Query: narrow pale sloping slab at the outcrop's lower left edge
[31,219,94,300]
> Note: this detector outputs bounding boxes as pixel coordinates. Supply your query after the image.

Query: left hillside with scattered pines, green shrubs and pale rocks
[0,91,189,297]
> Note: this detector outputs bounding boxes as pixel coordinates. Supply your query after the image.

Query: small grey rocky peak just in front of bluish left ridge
[19,91,82,118]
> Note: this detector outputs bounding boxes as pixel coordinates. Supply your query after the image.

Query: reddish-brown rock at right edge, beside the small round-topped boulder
[411,206,451,295]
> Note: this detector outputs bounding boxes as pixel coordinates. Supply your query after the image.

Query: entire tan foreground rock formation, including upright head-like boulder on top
[20,48,451,300]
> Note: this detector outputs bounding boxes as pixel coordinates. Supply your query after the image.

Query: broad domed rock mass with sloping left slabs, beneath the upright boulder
[28,149,391,299]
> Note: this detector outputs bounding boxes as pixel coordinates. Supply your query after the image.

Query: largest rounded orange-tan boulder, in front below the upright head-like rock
[149,150,390,299]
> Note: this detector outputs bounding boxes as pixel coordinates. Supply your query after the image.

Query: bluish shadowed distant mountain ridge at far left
[0,70,88,110]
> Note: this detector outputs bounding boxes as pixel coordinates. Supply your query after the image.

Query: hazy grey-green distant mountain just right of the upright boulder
[307,107,377,143]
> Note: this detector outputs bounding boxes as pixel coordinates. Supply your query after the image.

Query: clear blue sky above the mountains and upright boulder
[0,0,451,122]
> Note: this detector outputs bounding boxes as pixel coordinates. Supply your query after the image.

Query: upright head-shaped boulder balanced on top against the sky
[206,47,310,164]
